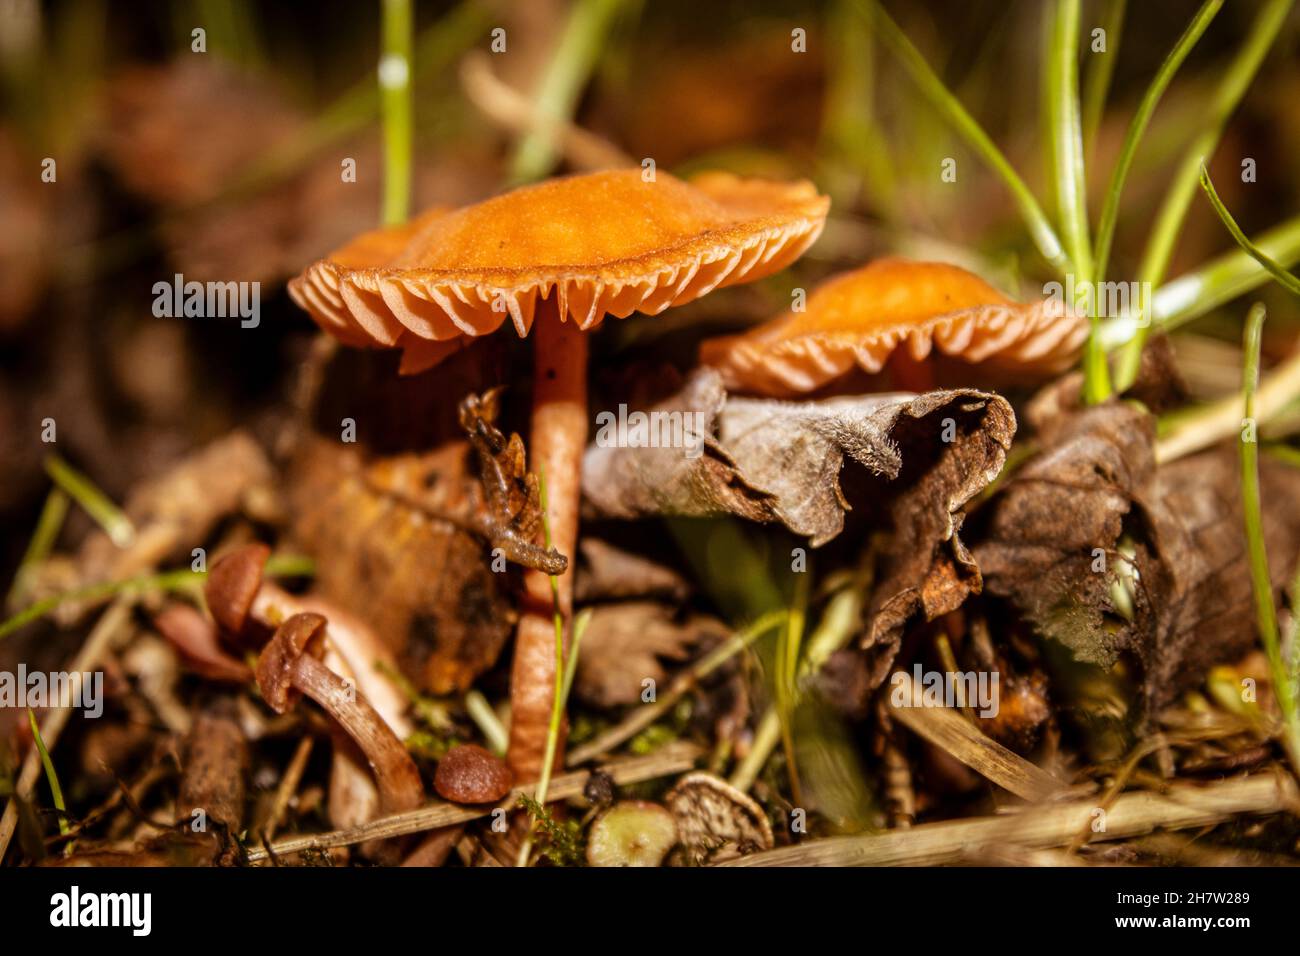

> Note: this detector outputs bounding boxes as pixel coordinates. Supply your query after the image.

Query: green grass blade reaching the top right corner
[1117,0,1294,389]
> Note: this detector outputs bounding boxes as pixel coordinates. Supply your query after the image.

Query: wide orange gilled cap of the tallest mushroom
[289,169,829,373]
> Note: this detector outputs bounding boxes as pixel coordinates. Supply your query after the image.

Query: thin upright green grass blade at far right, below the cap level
[1239,303,1300,773]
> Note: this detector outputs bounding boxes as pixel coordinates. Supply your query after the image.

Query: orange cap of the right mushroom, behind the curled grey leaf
[699,259,1088,397]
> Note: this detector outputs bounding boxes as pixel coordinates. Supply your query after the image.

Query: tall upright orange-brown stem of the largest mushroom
[506,310,586,780]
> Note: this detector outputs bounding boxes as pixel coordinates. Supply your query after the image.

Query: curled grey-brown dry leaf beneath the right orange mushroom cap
[582,368,1015,685]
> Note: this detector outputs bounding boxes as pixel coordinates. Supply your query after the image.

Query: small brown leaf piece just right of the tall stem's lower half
[573,601,727,708]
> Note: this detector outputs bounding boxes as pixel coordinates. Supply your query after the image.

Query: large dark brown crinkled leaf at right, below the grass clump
[975,403,1300,708]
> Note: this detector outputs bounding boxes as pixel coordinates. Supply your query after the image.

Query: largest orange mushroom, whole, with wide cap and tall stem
[290,169,829,779]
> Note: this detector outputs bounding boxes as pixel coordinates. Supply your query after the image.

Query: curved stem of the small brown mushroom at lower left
[290,654,424,813]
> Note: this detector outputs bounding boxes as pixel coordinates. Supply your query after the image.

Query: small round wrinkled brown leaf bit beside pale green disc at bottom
[664,771,775,866]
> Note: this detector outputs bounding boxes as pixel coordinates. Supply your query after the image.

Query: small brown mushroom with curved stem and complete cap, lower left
[256,614,424,813]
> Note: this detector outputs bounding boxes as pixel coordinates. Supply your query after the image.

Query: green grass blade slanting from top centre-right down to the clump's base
[859,0,1070,277]
